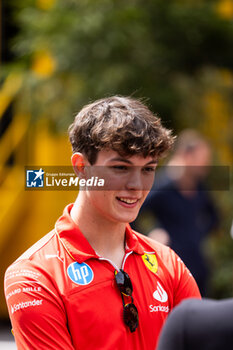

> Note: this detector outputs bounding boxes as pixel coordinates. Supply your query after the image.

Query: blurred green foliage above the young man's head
[6,0,233,129]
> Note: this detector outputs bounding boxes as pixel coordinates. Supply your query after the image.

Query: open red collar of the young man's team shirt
[55,204,144,263]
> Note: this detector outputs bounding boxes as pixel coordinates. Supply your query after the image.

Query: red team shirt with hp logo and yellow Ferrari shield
[5,205,200,350]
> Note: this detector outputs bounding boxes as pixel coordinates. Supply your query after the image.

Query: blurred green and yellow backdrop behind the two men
[0,0,233,340]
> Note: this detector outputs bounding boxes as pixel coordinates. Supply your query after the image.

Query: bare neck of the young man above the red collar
[71,194,126,268]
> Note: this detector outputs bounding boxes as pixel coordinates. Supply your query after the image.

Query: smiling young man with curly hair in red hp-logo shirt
[5,96,200,350]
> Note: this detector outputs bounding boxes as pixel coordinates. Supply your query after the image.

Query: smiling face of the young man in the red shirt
[85,150,157,223]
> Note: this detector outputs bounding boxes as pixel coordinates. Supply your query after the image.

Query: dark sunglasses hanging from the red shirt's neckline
[115,269,138,332]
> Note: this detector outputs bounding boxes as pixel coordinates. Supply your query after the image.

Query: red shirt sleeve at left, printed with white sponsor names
[4,260,75,350]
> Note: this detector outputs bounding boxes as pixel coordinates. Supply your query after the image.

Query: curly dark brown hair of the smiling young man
[69,96,174,164]
